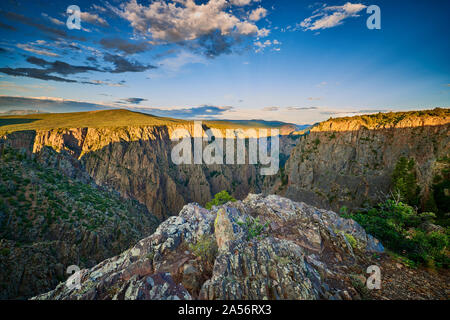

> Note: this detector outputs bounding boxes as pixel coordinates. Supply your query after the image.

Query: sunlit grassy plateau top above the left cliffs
[0,110,292,133]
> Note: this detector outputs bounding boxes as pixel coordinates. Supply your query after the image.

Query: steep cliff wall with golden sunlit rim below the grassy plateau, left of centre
[4,125,296,218]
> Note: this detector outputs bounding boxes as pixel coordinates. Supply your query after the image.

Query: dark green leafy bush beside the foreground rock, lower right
[345,200,449,268]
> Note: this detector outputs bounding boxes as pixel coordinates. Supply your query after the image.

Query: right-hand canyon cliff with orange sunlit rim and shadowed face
[263,109,450,210]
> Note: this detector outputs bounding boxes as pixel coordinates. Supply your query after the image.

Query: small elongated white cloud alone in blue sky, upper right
[300,2,367,31]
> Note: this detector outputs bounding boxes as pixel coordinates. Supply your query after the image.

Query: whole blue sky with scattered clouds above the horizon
[0,0,450,124]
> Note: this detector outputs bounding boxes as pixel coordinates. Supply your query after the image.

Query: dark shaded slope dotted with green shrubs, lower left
[0,144,159,299]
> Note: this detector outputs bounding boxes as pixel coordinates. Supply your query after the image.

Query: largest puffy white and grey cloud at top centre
[109,0,267,57]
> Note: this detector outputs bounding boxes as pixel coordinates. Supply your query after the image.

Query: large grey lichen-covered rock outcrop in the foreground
[34,195,384,300]
